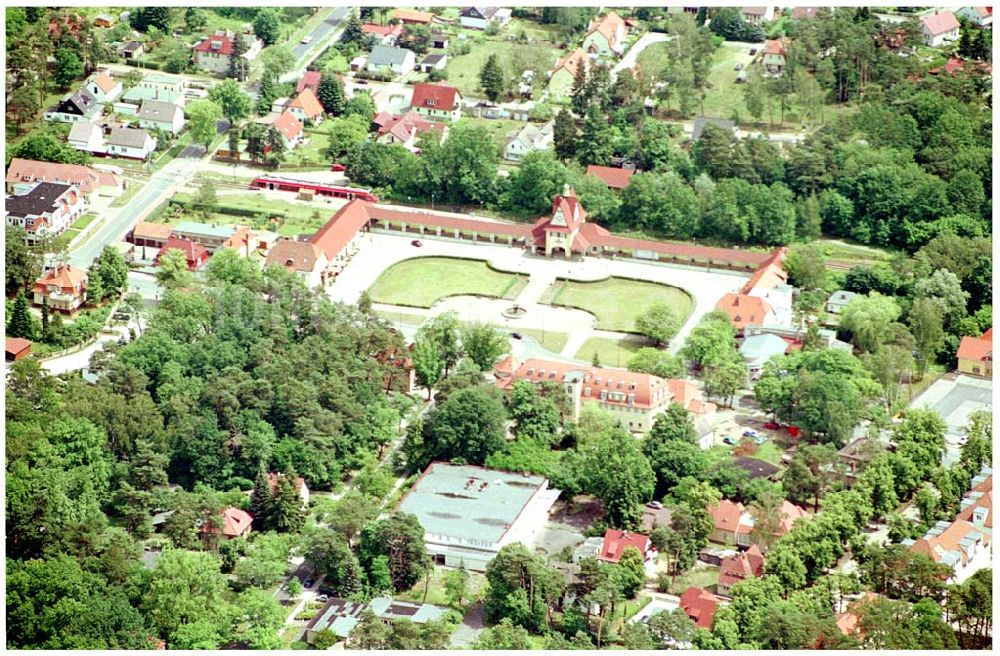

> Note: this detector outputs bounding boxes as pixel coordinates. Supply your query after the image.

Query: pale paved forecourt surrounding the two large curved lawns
[327,232,748,356]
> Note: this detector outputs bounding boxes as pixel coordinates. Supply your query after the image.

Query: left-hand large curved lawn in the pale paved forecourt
[369,257,527,307]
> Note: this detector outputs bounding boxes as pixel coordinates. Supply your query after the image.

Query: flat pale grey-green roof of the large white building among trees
[397,462,546,542]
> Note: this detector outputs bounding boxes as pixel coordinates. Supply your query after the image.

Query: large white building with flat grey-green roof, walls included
[396,462,560,572]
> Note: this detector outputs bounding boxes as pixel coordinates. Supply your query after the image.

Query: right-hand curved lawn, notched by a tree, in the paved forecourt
[540,277,693,333]
